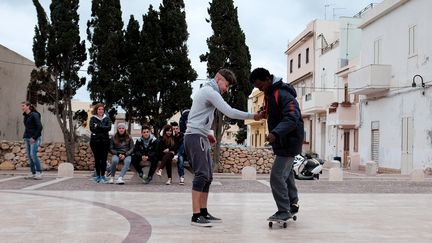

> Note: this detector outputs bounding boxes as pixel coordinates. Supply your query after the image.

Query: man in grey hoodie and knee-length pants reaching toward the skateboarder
[184,69,260,226]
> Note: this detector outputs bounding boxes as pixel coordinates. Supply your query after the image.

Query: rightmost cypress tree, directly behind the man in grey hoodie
[200,0,252,163]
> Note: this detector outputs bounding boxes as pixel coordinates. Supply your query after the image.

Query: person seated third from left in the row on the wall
[156,125,177,185]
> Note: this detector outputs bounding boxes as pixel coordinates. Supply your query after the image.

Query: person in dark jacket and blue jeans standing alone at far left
[21,101,42,180]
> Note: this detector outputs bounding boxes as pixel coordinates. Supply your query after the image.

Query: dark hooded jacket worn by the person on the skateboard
[266,76,304,157]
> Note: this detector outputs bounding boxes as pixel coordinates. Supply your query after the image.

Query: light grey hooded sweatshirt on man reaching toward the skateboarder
[186,79,254,136]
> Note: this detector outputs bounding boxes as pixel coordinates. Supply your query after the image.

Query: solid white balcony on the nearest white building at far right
[348,64,391,95]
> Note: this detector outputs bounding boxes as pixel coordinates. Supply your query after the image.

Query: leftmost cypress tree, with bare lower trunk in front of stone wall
[28,0,86,163]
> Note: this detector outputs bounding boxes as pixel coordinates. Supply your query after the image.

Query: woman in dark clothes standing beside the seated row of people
[90,103,111,183]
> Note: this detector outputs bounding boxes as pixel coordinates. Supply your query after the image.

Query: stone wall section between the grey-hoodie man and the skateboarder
[218,147,274,174]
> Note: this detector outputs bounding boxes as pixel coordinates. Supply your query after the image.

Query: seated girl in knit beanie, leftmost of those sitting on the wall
[108,123,134,184]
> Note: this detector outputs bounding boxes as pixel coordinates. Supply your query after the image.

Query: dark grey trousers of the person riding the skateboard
[270,156,298,212]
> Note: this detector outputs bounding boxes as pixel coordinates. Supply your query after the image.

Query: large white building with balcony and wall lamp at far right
[348,0,432,174]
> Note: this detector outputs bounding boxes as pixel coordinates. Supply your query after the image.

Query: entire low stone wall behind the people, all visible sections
[0,141,274,174]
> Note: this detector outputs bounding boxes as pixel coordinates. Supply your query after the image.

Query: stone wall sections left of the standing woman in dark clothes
[0,141,94,170]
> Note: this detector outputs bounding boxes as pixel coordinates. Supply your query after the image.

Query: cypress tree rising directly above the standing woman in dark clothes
[87,0,123,108]
